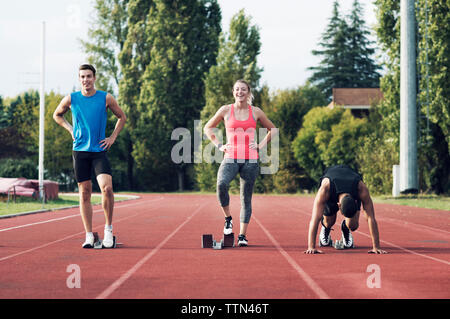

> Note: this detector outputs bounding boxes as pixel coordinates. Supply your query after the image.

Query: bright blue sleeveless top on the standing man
[70,90,107,152]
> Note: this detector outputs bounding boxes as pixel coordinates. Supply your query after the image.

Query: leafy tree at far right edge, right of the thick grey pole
[416,0,450,194]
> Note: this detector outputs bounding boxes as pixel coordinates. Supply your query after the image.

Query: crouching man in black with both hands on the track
[305,165,386,254]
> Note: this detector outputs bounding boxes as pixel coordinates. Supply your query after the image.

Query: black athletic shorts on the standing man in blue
[72,151,112,183]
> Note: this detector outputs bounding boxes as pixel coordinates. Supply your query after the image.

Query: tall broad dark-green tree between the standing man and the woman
[128,0,221,190]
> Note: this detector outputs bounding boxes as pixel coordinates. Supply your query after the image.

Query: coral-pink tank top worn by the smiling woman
[225,104,258,159]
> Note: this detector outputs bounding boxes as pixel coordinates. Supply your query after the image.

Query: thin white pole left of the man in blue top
[39,21,45,201]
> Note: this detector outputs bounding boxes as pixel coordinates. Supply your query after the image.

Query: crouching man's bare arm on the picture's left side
[305,178,330,254]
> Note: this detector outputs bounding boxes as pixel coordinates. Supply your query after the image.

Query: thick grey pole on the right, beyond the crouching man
[400,0,419,193]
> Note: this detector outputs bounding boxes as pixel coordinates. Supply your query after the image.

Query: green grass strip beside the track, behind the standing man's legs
[0,194,134,216]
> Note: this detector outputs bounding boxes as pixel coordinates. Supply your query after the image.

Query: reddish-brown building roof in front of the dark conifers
[328,88,383,109]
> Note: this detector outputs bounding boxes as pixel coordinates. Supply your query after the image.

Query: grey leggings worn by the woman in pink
[217,158,259,224]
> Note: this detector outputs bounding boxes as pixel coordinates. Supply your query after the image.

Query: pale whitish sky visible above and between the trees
[0,0,376,97]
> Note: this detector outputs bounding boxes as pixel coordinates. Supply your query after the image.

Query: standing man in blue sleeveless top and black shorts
[53,64,126,248]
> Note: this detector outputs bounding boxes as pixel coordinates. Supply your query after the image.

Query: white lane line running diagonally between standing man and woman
[96,203,208,299]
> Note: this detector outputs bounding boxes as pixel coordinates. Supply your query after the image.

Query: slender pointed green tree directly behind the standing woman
[195,10,262,191]
